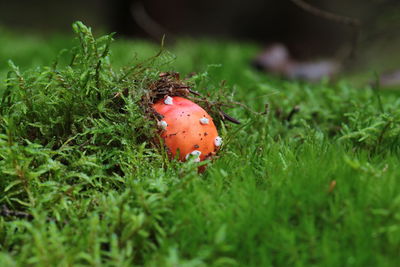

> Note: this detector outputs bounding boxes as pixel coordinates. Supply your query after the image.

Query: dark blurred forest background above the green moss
[0,0,400,82]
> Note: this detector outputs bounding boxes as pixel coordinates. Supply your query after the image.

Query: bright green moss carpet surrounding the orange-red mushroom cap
[0,22,400,266]
